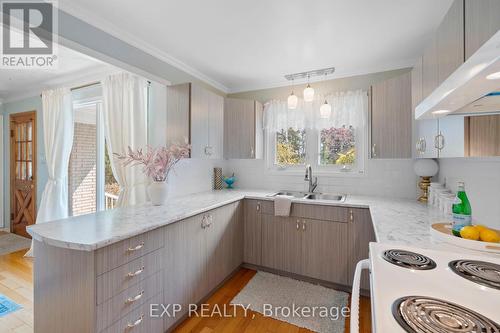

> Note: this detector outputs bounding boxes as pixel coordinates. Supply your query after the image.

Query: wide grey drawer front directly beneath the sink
[290,203,350,223]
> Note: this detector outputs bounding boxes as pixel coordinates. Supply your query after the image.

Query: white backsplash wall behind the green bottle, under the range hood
[439,158,500,229]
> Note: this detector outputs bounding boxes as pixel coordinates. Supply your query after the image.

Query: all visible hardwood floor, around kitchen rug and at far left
[0,250,371,333]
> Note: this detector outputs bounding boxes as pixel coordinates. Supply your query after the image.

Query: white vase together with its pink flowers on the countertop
[115,144,191,206]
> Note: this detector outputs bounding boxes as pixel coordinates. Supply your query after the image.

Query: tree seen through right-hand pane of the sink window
[319,126,356,165]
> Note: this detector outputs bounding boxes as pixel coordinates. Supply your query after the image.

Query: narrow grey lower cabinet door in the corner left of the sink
[243,199,262,265]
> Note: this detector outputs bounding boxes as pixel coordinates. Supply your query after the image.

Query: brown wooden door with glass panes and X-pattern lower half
[10,111,36,238]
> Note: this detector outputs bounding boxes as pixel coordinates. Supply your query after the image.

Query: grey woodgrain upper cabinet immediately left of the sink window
[224,98,255,159]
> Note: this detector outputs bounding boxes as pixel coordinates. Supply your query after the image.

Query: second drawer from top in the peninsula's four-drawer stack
[96,250,162,304]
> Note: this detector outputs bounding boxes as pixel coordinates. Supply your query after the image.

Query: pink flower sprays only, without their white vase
[115,144,191,182]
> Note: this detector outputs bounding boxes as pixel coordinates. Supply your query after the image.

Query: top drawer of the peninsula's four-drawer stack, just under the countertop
[96,229,163,275]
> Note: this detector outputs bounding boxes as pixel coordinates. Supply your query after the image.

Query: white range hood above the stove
[415,31,500,119]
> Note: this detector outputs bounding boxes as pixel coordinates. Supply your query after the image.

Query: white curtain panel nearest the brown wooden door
[25,88,74,256]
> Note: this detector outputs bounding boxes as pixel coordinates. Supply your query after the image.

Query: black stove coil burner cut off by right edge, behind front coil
[448,260,500,290]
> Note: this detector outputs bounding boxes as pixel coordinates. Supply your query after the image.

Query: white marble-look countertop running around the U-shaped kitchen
[28,190,450,251]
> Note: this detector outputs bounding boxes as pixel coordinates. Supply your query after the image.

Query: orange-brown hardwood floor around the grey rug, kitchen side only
[174,268,371,333]
